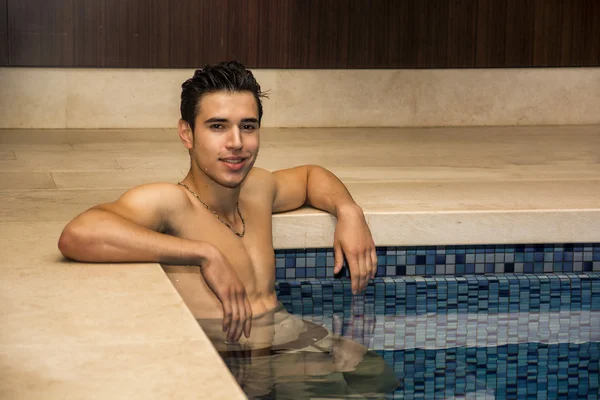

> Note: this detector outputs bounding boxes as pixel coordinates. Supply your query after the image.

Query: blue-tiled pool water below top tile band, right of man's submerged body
[277,272,600,399]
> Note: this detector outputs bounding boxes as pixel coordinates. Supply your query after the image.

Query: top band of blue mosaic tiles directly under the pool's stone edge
[275,243,600,280]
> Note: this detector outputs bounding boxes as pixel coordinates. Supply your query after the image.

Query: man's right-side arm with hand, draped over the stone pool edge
[273,165,377,294]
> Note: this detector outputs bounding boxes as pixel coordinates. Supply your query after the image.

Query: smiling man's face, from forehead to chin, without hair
[191,91,259,188]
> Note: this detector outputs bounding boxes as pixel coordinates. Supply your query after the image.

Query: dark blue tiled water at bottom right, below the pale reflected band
[380,342,600,399]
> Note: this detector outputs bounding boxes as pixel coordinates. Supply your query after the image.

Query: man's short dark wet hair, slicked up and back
[180,61,267,132]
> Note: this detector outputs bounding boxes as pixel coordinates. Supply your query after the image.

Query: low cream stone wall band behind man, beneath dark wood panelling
[0,68,600,128]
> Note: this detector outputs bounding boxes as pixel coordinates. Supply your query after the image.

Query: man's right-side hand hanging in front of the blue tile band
[333,206,377,294]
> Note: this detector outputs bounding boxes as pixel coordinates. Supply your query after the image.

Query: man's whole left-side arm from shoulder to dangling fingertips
[58,183,252,341]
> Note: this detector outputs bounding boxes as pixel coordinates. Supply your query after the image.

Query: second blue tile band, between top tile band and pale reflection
[276,272,600,322]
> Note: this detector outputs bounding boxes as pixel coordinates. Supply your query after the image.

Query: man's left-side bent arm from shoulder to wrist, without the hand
[58,184,210,265]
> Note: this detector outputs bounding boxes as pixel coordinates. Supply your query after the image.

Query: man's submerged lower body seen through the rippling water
[198,305,398,400]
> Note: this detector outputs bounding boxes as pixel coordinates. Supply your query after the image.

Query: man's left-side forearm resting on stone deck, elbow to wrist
[58,209,211,265]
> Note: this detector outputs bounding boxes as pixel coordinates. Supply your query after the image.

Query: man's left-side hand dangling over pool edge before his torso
[200,247,252,342]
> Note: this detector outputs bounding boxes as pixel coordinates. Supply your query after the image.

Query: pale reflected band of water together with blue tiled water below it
[303,310,600,399]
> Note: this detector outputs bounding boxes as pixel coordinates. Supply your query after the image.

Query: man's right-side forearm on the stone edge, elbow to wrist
[306,166,362,217]
